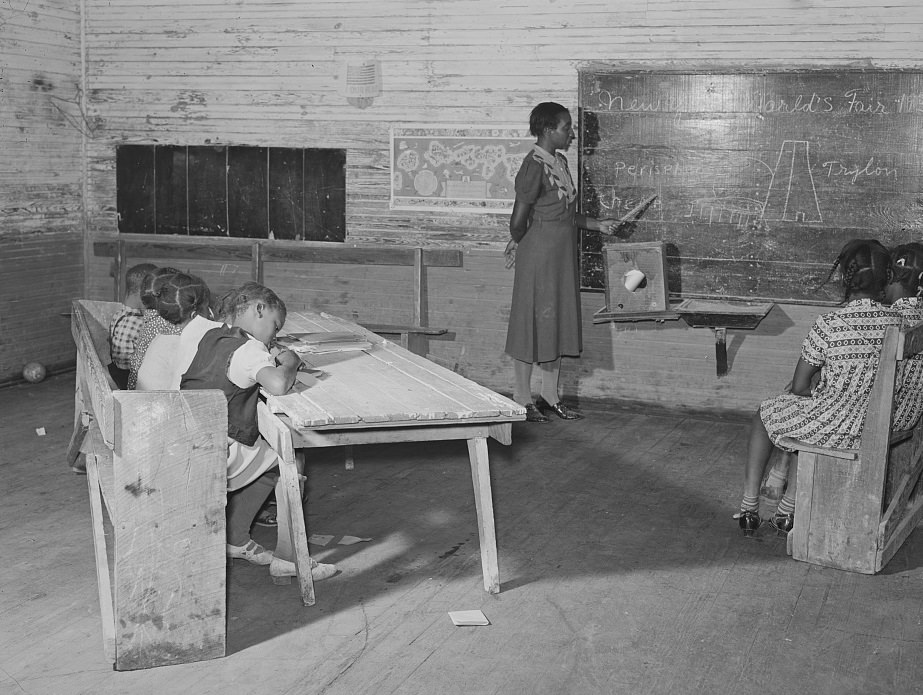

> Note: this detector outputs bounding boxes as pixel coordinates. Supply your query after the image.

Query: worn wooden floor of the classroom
[0,374,923,695]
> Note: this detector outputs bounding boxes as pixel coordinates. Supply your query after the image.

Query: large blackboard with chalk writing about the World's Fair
[579,69,923,301]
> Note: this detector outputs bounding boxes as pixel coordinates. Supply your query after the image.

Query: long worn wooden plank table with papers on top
[267,312,525,604]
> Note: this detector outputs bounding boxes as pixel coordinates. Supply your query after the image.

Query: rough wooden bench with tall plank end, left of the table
[71,300,227,671]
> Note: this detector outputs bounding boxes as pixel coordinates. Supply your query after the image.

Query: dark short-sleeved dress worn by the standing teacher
[506,150,583,363]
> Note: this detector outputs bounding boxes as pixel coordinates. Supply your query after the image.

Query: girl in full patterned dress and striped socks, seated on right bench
[736,239,901,536]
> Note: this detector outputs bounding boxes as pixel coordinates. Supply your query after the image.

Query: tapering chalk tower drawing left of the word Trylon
[763,140,823,222]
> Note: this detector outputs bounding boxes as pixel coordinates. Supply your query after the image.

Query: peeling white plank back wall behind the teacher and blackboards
[34,0,923,410]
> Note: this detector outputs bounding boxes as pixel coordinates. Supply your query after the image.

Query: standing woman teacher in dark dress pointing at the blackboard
[504,101,618,422]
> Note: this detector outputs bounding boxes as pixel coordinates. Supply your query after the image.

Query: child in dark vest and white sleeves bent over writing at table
[180,282,337,581]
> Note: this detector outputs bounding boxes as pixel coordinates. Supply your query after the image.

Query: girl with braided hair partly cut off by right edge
[885,241,923,430]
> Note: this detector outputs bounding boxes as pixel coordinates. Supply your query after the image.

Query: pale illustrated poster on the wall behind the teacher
[391,126,534,214]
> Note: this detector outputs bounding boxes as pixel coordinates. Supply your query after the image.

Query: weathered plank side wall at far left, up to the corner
[0,0,84,383]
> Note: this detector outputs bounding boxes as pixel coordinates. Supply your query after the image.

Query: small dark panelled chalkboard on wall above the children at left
[116,145,346,241]
